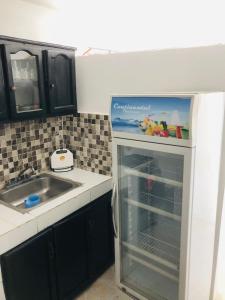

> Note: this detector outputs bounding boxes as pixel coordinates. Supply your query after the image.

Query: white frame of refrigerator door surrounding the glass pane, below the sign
[112,138,195,300]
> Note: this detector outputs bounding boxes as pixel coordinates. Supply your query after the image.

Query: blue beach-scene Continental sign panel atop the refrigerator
[111,96,191,140]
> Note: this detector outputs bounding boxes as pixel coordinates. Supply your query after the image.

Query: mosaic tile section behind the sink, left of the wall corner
[0,117,63,185]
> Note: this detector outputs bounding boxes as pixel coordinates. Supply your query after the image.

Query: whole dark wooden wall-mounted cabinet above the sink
[0,37,77,120]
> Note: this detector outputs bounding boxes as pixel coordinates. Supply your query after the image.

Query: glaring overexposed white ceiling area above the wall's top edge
[19,0,225,51]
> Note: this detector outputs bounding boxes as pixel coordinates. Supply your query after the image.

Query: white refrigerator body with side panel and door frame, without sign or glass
[111,92,225,300]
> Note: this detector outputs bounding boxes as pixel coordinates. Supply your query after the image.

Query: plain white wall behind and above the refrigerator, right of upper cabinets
[77,45,225,114]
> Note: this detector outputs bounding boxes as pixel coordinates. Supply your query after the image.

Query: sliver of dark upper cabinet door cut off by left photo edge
[0,48,8,121]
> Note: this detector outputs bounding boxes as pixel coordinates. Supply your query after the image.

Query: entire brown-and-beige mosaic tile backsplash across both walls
[0,114,112,186]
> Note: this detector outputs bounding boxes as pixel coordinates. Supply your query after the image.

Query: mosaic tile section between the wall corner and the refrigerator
[63,114,112,175]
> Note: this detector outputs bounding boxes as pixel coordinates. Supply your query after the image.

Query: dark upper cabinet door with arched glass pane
[4,44,46,120]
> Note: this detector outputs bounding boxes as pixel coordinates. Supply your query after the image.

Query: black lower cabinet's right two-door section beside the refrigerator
[53,192,114,300]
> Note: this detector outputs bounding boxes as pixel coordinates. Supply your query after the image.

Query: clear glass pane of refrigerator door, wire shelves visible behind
[117,141,192,300]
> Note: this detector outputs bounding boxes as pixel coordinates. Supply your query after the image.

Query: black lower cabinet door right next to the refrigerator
[87,192,114,278]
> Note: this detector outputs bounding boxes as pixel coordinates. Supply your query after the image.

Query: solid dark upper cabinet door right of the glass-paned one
[45,50,77,115]
